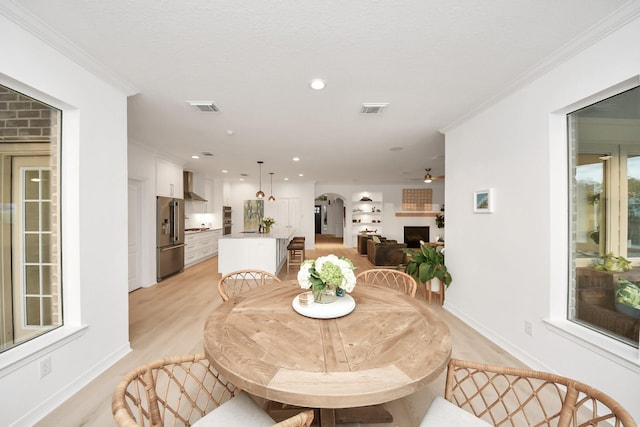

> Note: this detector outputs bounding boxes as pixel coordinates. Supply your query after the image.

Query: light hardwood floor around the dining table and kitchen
[37,237,524,427]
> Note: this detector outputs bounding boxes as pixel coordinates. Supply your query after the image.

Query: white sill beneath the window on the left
[0,325,89,378]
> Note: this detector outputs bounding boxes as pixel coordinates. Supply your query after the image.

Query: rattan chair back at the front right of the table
[423,359,637,427]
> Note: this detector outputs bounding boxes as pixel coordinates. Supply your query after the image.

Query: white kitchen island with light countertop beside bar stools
[218,228,295,274]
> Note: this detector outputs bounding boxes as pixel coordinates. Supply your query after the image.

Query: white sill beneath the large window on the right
[544,319,640,373]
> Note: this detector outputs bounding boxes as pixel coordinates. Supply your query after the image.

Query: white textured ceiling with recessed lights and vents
[7,0,626,184]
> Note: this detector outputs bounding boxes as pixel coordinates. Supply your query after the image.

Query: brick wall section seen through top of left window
[0,86,56,143]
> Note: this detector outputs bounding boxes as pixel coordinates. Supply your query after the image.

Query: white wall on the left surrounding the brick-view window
[0,11,130,426]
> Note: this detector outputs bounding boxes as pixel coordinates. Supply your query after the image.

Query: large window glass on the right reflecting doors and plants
[567,88,640,347]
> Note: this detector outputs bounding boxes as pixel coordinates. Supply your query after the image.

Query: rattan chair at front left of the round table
[111,354,313,427]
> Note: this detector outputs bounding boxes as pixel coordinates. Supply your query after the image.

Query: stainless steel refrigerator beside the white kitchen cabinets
[156,196,184,282]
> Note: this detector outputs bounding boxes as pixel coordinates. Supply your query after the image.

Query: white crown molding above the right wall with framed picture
[440,0,640,134]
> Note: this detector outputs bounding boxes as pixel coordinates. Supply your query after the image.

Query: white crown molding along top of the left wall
[0,0,140,96]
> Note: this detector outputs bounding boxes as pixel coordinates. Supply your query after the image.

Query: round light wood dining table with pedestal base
[203,280,451,426]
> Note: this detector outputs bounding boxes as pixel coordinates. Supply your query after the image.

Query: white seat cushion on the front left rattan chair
[192,391,276,427]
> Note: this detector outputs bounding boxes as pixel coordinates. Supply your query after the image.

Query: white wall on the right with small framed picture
[445,14,640,420]
